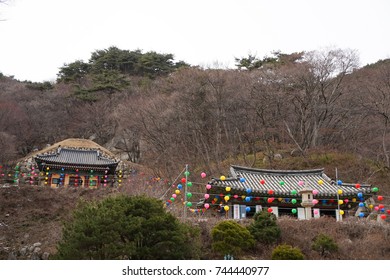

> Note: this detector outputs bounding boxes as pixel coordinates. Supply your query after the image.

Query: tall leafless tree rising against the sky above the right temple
[279,49,358,153]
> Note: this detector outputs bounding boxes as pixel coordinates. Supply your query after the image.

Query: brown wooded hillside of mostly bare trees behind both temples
[0,47,390,190]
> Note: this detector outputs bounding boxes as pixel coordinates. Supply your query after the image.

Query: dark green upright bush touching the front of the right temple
[248,211,281,244]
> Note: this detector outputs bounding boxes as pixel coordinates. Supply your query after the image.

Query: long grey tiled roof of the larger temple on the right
[211,165,371,197]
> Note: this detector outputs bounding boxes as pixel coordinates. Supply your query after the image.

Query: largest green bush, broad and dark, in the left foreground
[54,195,200,260]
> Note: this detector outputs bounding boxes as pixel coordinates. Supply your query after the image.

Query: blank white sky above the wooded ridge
[0,0,390,82]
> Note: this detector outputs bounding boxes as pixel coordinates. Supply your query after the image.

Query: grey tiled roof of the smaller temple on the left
[35,148,118,166]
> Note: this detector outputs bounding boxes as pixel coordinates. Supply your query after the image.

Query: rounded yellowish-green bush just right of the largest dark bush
[211,221,255,257]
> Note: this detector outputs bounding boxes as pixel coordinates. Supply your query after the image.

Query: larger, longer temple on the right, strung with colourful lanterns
[204,165,376,220]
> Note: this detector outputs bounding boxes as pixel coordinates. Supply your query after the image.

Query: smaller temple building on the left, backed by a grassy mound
[34,146,119,187]
